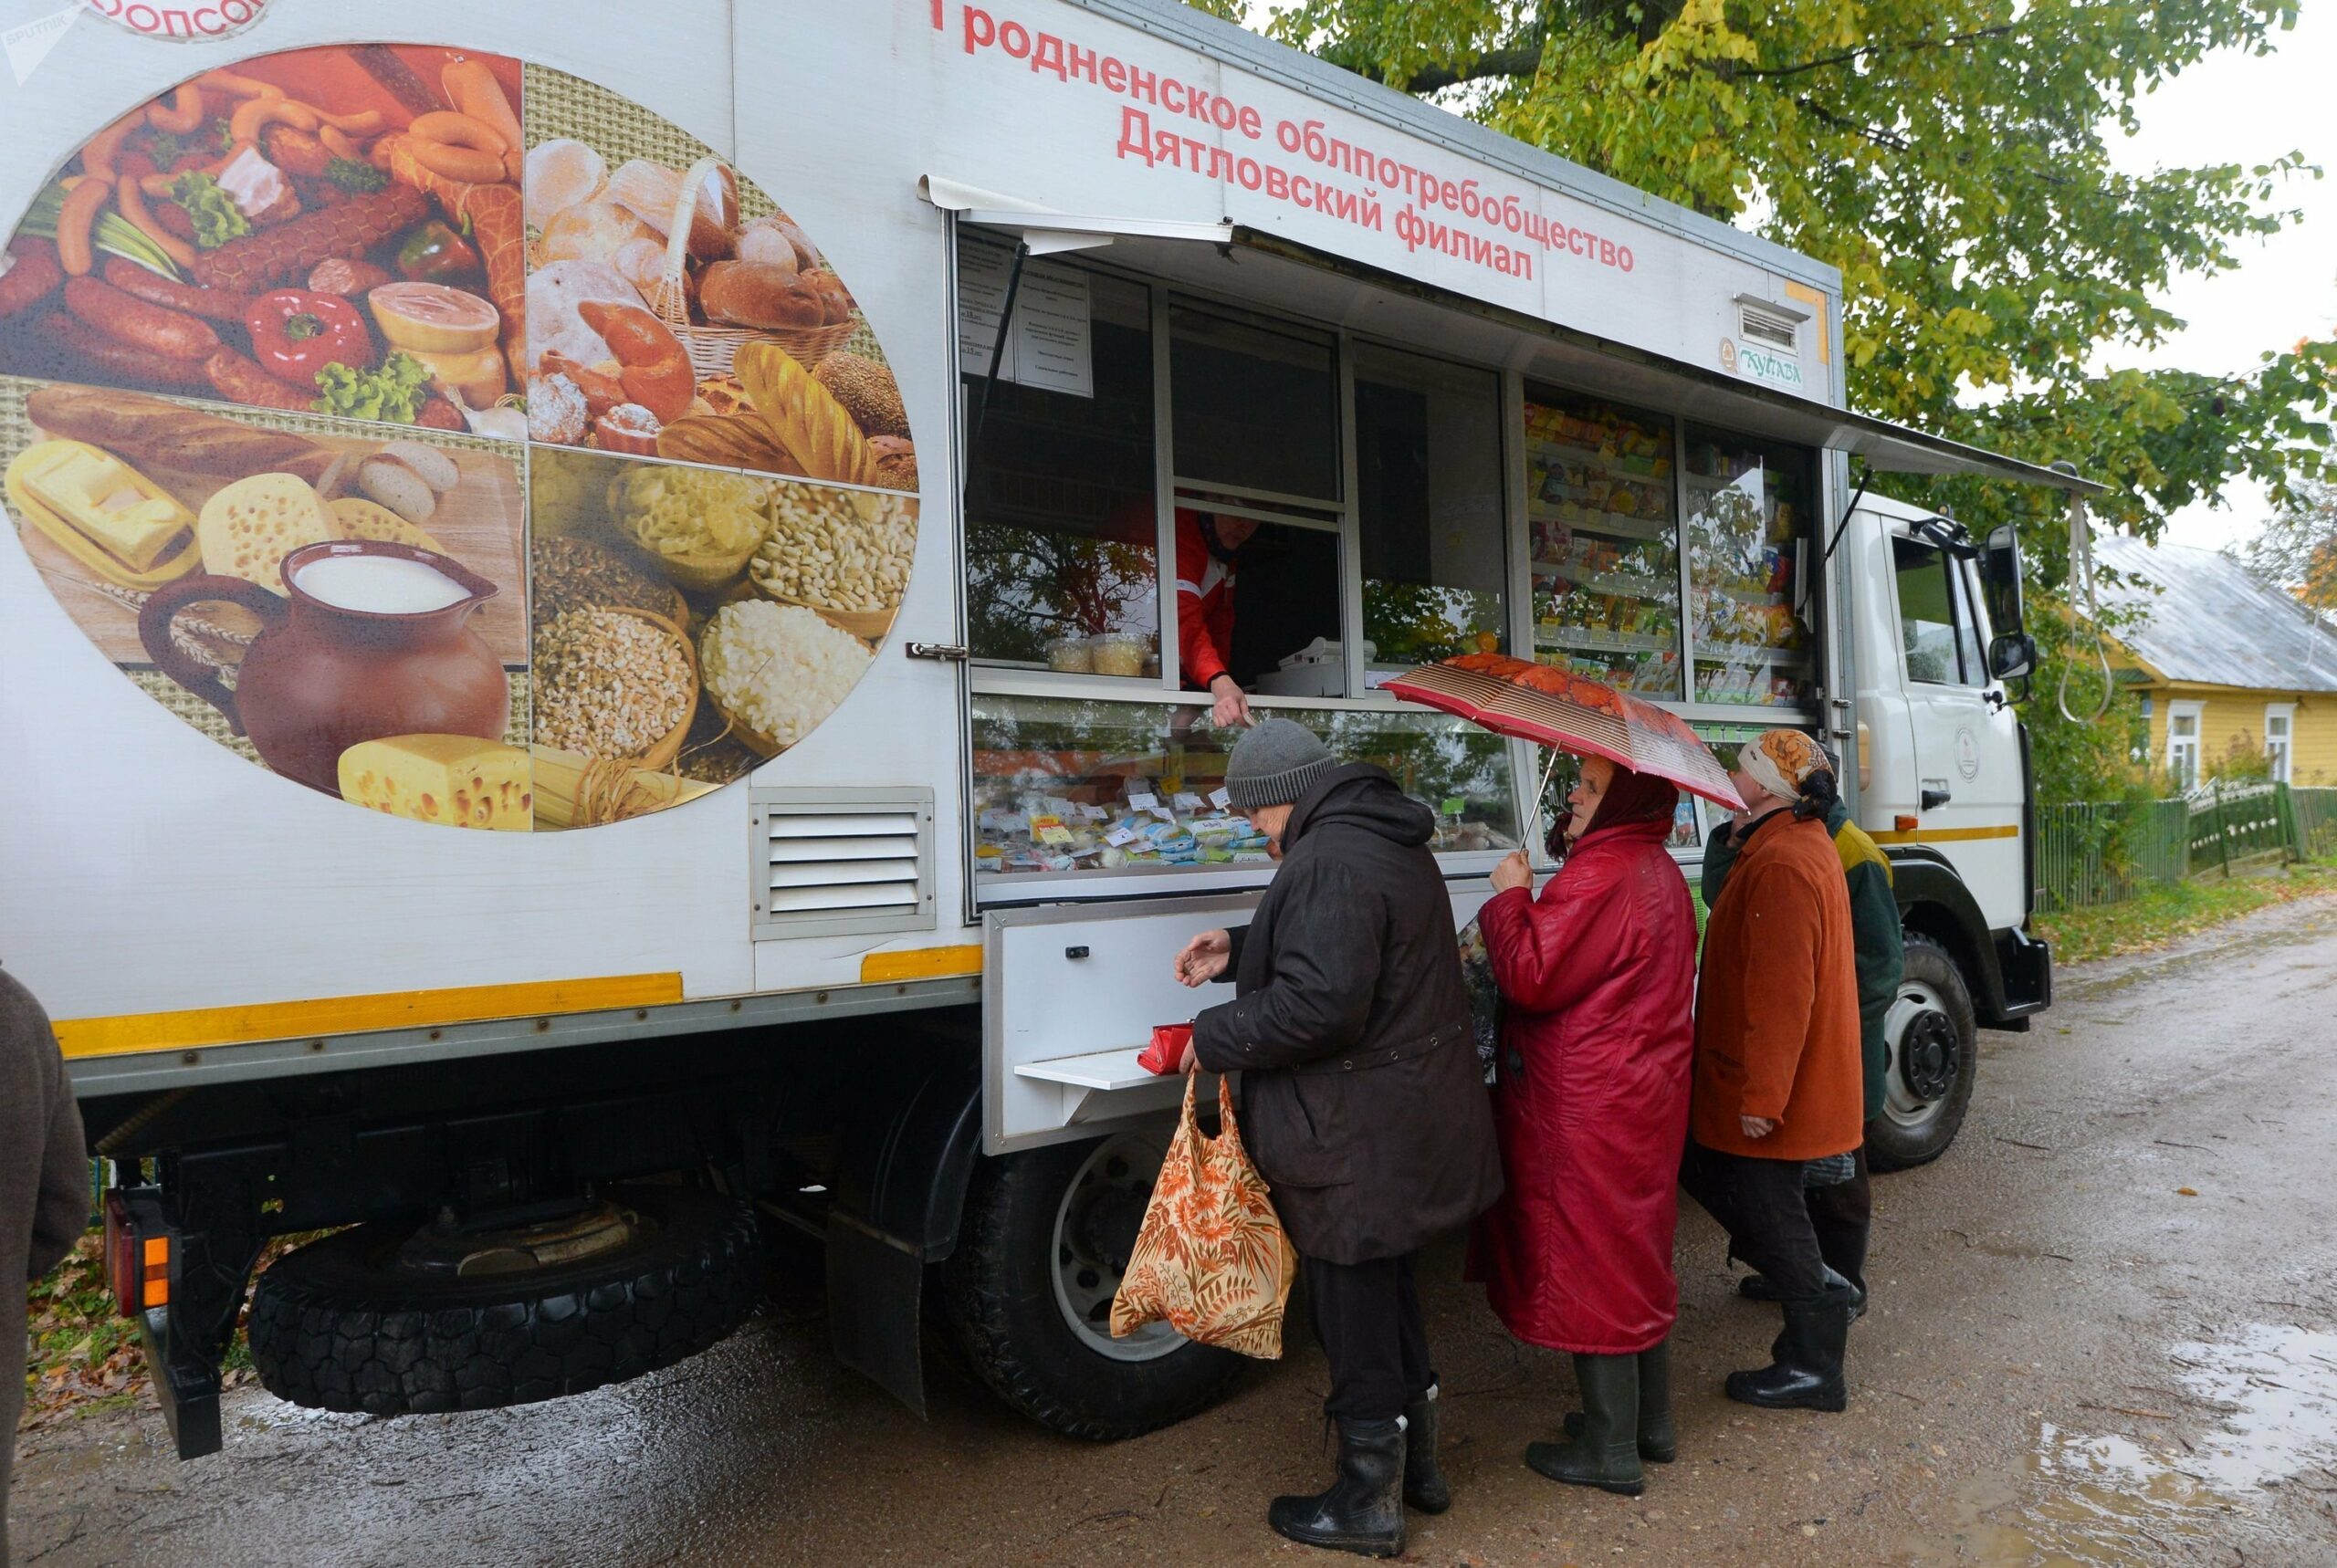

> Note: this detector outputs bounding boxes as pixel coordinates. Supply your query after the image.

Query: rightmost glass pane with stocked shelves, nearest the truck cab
[1687,430,1816,708]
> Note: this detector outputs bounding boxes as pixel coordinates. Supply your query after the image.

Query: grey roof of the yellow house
[2094,535,2337,692]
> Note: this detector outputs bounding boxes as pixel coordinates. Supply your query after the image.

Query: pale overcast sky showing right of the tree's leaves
[2112,0,2337,549]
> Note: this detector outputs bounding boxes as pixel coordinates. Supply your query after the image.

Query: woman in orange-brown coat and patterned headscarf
[1681,729,1865,1411]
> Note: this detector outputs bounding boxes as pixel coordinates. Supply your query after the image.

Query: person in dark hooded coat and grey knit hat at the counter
[1178,720,1501,1556]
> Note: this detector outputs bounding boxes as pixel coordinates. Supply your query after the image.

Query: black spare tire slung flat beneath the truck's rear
[250,1187,762,1416]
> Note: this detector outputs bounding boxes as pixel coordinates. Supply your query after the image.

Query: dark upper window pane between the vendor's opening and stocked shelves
[1356,343,1507,685]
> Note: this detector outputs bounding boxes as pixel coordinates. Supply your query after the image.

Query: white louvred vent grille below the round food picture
[750,789,935,942]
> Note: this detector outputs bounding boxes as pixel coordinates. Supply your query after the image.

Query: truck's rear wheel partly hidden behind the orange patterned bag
[942,1129,1241,1442]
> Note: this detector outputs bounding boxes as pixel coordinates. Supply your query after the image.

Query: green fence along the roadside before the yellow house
[2038,783,2337,909]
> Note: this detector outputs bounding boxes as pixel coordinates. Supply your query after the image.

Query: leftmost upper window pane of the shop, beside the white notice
[960,253,1159,675]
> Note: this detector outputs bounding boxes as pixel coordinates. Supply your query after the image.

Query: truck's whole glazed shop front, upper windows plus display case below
[960,231,1816,897]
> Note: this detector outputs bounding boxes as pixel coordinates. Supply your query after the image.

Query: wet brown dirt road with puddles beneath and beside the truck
[14,900,2337,1568]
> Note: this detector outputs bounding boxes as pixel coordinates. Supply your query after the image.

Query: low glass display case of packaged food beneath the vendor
[972,694,1516,881]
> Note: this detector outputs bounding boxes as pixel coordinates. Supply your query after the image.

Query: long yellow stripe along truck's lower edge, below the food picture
[56,972,683,1056]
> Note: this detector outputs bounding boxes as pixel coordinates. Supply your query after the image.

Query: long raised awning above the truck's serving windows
[918,175,2108,496]
